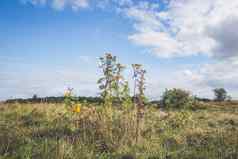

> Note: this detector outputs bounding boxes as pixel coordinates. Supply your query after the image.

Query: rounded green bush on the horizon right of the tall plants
[162,88,193,108]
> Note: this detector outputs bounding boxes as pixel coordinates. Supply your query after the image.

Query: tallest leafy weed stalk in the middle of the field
[98,53,130,143]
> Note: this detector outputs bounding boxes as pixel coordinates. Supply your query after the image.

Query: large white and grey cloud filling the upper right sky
[125,0,238,57]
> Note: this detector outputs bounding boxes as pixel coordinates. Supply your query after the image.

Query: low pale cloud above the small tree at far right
[180,60,238,99]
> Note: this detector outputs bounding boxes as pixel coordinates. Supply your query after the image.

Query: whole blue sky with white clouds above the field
[0,0,238,100]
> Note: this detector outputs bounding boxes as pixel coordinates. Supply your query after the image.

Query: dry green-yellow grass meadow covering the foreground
[0,103,238,159]
